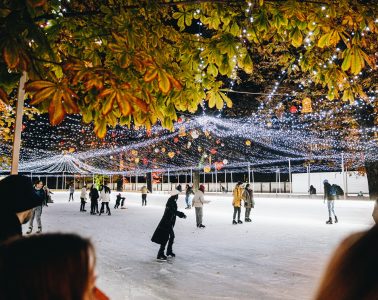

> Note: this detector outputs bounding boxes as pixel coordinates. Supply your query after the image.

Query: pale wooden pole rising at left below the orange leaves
[11,72,27,175]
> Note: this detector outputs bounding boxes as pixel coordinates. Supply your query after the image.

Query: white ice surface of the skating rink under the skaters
[23,192,373,300]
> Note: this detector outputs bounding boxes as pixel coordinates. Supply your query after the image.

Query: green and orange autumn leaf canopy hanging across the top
[0,0,378,138]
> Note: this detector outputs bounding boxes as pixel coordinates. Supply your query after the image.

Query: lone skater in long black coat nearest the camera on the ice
[151,194,186,260]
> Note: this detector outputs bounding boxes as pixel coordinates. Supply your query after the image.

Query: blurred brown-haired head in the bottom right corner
[315,225,378,300]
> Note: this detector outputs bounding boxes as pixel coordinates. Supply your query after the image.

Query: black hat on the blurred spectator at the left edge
[0,175,42,213]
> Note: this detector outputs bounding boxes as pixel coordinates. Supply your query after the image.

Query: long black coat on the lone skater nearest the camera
[151,195,186,245]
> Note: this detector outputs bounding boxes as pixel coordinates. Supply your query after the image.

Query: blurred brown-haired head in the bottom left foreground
[0,233,109,300]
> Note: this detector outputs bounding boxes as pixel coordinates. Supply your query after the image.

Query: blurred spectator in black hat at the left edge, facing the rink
[0,175,42,243]
